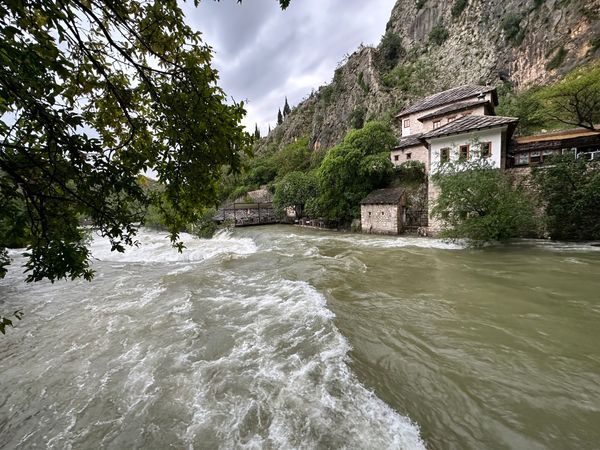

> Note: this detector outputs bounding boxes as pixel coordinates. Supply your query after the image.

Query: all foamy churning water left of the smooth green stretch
[0,232,424,449]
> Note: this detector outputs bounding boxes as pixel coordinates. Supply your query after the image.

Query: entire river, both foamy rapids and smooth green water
[0,226,600,449]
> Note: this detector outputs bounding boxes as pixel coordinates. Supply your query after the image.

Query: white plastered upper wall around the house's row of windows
[428,127,506,173]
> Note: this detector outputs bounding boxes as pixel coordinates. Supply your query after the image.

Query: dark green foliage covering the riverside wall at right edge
[532,154,600,240]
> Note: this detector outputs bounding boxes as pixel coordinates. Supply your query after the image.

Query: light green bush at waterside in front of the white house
[432,160,537,245]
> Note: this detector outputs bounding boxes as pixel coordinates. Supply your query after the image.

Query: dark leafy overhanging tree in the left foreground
[0,0,289,330]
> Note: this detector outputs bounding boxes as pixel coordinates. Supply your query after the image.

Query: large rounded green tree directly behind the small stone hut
[313,122,396,223]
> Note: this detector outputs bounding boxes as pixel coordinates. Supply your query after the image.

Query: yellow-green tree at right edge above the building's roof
[538,61,600,130]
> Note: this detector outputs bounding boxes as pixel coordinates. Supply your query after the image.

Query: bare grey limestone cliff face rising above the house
[259,0,600,151]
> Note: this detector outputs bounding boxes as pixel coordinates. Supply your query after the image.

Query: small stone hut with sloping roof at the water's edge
[360,188,406,234]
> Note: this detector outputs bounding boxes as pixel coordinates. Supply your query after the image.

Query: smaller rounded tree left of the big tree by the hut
[273,172,318,219]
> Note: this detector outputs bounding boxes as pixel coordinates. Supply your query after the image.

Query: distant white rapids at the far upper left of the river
[91,230,256,264]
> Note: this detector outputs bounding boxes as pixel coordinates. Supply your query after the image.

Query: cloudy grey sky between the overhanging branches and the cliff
[184,0,395,135]
